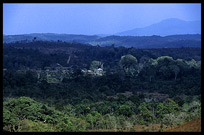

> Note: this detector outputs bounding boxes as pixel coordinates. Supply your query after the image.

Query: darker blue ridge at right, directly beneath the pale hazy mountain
[88,34,201,48]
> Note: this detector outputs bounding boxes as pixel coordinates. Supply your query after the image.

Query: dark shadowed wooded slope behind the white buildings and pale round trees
[3,41,201,69]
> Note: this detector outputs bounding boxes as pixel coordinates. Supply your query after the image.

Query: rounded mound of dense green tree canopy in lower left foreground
[4,97,60,124]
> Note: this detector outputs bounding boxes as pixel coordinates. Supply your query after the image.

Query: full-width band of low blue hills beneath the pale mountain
[3,33,201,48]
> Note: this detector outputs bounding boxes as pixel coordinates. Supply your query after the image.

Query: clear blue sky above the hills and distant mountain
[3,3,201,35]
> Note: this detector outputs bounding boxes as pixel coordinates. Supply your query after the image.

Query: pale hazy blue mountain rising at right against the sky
[115,18,201,36]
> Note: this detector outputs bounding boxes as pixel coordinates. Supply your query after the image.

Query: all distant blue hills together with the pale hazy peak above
[3,18,201,48]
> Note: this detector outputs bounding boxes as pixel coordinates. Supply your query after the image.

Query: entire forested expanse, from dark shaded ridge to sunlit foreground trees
[3,40,201,132]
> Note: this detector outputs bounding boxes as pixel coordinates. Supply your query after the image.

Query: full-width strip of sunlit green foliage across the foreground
[3,96,201,132]
